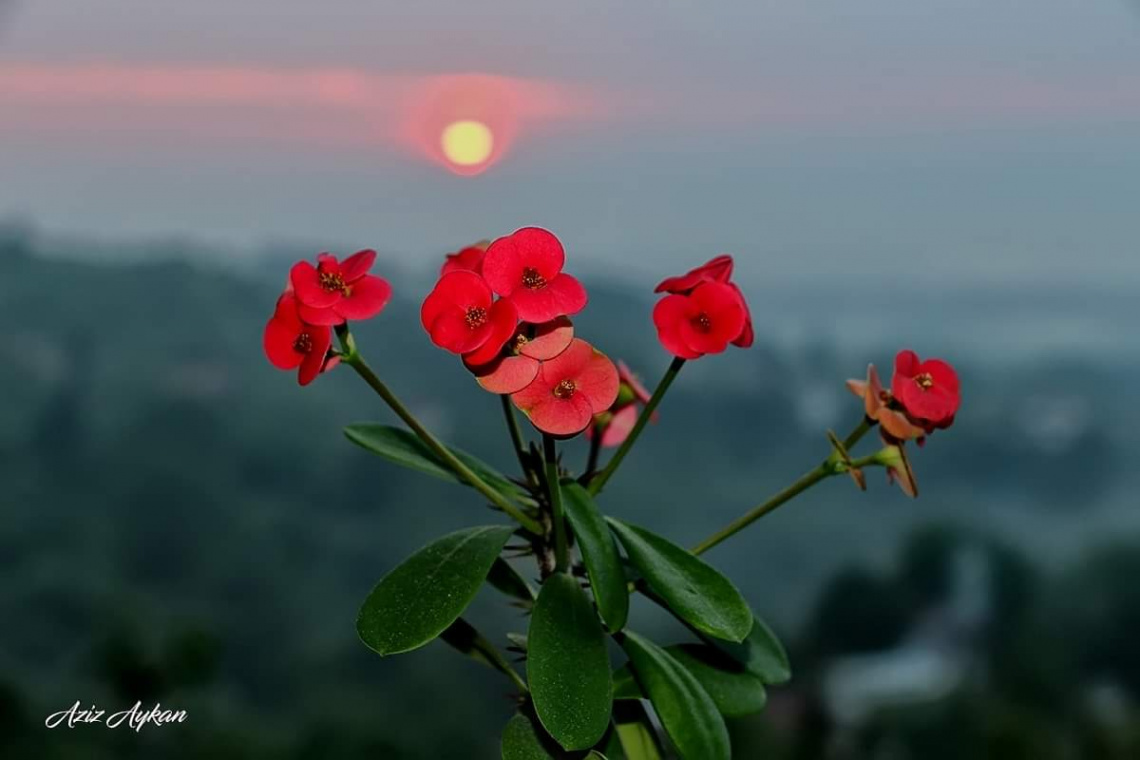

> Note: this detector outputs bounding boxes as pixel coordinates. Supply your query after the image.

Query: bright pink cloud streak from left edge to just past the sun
[0,64,604,164]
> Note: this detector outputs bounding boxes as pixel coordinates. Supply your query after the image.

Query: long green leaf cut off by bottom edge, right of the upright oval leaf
[621,631,732,760]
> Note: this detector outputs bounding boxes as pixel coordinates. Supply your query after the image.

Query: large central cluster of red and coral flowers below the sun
[420,227,619,436]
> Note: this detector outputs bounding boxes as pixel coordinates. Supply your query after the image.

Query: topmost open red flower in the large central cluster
[483,227,587,324]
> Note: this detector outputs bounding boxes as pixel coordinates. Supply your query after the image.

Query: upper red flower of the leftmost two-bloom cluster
[290,251,392,325]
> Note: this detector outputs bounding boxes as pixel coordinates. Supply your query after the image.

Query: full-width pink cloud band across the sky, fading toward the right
[0,64,1140,160]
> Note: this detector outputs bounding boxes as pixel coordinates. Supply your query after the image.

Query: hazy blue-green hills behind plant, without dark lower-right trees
[0,228,1140,757]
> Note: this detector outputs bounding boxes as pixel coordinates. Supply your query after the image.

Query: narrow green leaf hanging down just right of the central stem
[562,481,629,631]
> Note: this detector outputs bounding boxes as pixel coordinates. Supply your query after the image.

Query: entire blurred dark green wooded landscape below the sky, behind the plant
[0,227,1140,760]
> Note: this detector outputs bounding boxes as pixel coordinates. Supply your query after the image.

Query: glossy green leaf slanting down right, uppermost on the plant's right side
[606,517,752,641]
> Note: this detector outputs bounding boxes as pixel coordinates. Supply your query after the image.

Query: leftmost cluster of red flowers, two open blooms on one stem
[262,251,392,385]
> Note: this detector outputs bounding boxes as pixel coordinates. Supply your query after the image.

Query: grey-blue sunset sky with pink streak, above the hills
[0,0,1140,285]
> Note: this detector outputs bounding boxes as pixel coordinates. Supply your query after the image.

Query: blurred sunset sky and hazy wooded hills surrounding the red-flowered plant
[0,0,1140,760]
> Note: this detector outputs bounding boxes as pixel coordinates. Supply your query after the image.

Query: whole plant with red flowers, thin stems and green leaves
[264,227,959,760]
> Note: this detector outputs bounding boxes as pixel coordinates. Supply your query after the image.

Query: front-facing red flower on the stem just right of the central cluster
[653,281,748,359]
